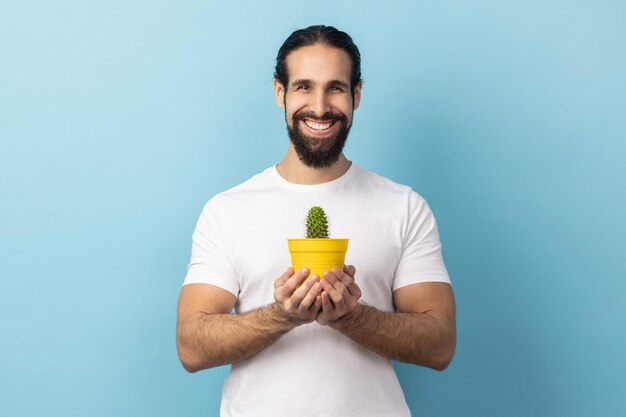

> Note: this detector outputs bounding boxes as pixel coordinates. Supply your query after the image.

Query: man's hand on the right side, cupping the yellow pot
[316,265,361,326]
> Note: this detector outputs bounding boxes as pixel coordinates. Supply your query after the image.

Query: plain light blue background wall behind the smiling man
[0,0,626,417]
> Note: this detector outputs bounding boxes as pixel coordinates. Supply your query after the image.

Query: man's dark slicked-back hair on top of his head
[274,25,361,96]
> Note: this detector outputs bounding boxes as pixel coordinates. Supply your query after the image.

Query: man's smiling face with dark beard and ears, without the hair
[274,44,361,168]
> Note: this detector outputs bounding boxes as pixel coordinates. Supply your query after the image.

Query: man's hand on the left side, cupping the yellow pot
[274,268,322,325]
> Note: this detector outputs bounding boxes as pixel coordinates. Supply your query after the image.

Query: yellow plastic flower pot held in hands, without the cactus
[287,239,349,279]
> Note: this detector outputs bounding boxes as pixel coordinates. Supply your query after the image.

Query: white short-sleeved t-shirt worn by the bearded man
[184,163,450,417]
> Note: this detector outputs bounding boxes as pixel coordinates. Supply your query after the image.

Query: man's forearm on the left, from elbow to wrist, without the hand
[177,304,296,372]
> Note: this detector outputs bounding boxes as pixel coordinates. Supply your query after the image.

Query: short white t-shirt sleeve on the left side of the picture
[183,197,239,295]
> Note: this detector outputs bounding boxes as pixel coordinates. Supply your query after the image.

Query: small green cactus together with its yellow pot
[287,206,348,279]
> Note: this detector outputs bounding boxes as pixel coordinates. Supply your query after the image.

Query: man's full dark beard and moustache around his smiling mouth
[287,112,351,168]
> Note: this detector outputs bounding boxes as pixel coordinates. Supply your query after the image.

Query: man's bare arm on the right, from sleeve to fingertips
[318,267,456,371]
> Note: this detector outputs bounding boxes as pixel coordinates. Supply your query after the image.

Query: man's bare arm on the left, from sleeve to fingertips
[176,268,321,372]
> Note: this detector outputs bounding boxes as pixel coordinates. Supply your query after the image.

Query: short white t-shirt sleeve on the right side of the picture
[392,191,450,291]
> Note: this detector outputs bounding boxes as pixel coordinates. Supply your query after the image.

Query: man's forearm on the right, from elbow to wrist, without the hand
[332,304,456,370]
